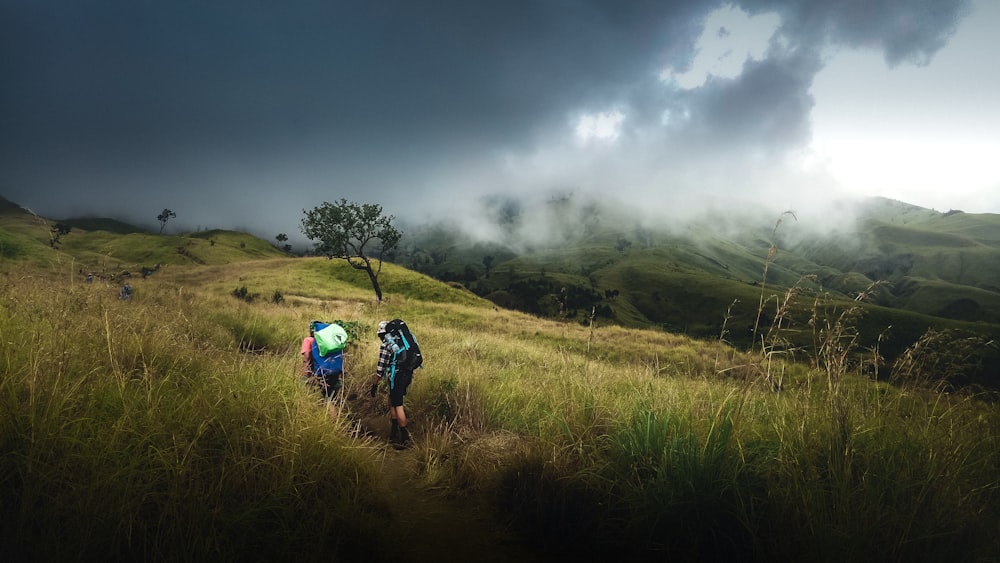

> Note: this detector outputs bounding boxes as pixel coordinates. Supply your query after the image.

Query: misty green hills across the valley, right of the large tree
[395,199,1000,384]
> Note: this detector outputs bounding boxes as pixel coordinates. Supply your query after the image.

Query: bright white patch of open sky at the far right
[811,0,1000,213]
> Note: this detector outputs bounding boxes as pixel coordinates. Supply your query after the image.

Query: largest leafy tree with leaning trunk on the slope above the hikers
[302,199,403,301]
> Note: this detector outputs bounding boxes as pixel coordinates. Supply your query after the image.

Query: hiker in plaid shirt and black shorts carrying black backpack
[369,319,423,448]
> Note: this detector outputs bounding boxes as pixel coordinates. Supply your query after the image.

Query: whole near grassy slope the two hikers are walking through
[0,205,1000,562]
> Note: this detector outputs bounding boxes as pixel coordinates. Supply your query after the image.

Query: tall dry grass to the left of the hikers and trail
[0,276,393,561]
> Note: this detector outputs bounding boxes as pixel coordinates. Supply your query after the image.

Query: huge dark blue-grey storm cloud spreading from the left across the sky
[0,0,965,238]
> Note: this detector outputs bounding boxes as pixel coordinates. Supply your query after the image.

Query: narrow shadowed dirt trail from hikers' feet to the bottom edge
[364,417,543,563]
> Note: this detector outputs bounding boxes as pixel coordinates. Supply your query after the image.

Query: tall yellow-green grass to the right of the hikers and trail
[394,268,1000,561]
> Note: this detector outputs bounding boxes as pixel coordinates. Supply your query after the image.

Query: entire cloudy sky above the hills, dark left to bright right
[0,0,1000,242]
